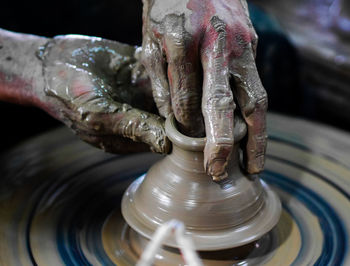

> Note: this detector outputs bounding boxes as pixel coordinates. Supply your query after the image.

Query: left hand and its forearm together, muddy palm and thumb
[0,29,170,153]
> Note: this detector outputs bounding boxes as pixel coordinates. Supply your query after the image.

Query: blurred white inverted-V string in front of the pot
[136,219,203,266]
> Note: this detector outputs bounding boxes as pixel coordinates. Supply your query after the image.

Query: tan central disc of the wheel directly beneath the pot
[101,197,301,266]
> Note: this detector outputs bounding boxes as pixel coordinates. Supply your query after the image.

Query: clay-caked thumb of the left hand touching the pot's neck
[75,98,170,153]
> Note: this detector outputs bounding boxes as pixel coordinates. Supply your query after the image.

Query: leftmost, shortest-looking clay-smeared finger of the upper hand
[141,35,171,117]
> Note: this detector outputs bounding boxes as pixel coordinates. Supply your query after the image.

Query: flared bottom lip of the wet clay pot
[122,176,281,251]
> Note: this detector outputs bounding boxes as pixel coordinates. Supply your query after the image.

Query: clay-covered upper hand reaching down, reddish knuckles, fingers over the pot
[142,0,267,180]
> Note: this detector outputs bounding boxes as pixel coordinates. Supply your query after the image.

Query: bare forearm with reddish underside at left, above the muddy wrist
[0,29,48,109]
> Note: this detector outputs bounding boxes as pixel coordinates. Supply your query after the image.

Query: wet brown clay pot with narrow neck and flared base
[122,116,281,251]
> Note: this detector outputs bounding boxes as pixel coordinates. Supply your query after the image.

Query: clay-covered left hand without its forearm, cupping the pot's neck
[40,36,169,153]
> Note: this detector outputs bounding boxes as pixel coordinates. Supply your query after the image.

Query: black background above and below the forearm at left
[0,0,142,151]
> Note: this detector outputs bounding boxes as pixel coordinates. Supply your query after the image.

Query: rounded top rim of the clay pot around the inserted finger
[165,114,247,151]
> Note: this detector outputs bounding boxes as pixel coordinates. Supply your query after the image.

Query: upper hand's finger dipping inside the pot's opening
[164,18,204,137]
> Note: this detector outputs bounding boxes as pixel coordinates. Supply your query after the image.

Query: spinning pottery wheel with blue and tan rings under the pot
[0,114,350,265]
